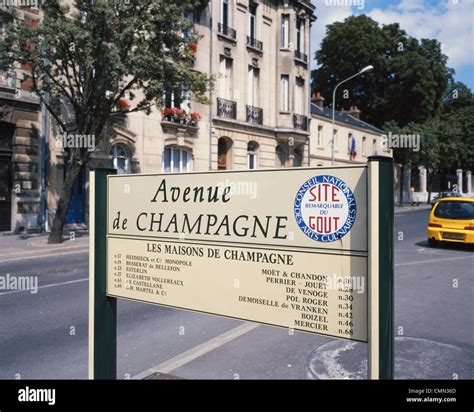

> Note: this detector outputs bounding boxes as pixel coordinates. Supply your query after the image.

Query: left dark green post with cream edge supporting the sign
[89,169,117,379]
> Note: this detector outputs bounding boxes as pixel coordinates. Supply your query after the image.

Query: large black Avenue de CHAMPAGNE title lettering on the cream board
[113,179,288,239]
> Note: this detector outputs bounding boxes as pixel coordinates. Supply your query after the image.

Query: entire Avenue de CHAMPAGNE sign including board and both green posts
[89,163,393,379]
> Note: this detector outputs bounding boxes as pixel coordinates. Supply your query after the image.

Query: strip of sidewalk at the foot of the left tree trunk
[0,232,89,261]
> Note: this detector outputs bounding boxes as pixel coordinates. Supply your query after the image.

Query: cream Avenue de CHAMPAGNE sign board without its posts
[106,165,369,342]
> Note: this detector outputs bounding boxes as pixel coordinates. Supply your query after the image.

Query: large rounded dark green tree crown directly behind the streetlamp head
[312,15,452,127]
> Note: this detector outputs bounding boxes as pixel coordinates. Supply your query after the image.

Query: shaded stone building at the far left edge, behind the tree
[0,8,44,231]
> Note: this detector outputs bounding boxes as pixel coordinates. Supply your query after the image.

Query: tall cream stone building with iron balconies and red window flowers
[124,0,315,180]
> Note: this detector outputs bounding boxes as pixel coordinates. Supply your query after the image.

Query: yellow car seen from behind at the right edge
[428,197,474,246]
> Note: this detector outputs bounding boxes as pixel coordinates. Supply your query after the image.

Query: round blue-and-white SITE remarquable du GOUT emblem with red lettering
[294,175,357,242]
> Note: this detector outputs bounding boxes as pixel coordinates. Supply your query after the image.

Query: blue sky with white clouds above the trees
[311,0,474,90]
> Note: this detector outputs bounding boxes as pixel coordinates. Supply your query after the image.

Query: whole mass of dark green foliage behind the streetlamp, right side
[312,15,474,172]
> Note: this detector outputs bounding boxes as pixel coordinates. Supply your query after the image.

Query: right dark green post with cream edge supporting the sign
[368,156,394,379]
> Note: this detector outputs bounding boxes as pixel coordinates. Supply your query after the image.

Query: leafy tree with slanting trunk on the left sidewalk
[0,0,210,243]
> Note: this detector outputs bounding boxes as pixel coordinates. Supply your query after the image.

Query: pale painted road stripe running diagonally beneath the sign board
[131,322,260,379]
